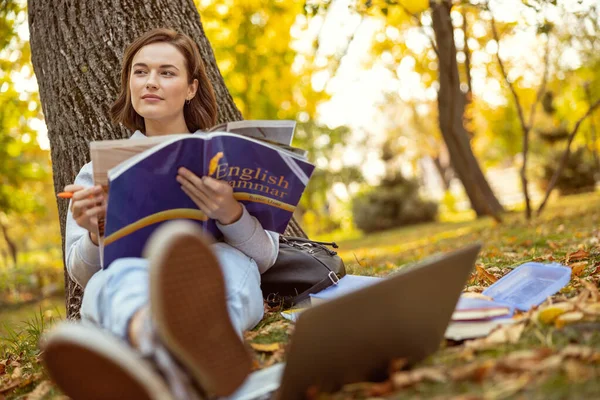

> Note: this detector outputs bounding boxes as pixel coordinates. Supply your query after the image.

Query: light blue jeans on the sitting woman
[81,243,264,340]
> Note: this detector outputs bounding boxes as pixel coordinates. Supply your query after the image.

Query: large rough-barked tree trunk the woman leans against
[28,0,306,318]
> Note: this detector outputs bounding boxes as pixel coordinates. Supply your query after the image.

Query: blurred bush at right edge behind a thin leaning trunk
[540,147,596,195]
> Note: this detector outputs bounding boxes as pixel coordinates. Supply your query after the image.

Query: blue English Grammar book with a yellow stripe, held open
[94,132,314,268]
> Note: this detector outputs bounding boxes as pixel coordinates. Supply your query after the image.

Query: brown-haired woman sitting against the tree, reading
[43,29,279,400]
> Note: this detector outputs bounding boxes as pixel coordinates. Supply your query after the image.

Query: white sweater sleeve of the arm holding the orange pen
[65,163,101,288]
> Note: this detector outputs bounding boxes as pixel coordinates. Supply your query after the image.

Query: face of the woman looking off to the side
[129,43,198,122]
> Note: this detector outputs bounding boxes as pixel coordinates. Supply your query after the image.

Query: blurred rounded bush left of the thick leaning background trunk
[352,176,438,232]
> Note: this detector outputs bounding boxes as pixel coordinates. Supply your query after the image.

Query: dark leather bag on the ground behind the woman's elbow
[261,236,346,308]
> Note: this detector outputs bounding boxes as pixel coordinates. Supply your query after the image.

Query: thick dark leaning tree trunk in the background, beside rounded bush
[431,0,504,219]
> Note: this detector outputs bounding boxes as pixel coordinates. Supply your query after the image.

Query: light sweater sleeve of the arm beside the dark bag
[217,206,279,274]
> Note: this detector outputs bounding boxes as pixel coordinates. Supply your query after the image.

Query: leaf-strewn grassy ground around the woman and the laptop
[0,194,600,399]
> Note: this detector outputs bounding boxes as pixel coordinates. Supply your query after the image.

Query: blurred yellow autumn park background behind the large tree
[0,0,600,393]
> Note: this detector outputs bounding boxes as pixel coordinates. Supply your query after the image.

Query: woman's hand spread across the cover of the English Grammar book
[177,167,243,225]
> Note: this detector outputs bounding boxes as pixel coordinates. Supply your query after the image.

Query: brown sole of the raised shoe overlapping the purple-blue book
[146,221,251,396]
